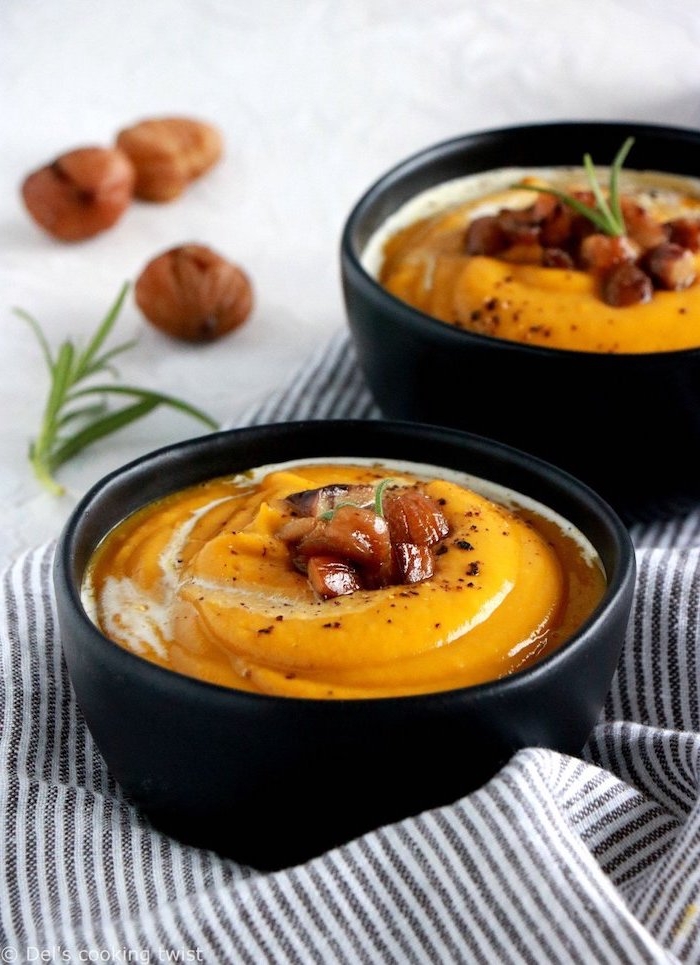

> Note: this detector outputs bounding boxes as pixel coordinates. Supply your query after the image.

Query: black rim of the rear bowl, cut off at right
[340,120,700,365]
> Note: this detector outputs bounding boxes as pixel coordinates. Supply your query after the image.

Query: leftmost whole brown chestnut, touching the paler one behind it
[21,147,136,241]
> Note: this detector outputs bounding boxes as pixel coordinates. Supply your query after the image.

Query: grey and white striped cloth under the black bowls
[0,338,700,965]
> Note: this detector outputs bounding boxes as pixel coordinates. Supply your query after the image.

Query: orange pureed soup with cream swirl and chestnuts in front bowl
[83,460,606,699]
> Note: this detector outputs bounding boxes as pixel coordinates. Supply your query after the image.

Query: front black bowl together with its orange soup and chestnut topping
[55,421,635,868]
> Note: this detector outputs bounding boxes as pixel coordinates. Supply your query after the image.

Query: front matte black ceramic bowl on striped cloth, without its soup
[54,421,635,868]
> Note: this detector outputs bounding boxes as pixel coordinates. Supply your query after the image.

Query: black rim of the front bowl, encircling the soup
[53,419,636,713]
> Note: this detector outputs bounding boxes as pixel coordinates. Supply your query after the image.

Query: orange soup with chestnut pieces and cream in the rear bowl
[363,158,700,353]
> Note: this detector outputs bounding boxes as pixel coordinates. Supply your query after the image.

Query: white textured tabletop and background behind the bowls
[0,0,700,566]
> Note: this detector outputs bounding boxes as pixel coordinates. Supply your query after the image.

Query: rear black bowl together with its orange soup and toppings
[341,122,700,516]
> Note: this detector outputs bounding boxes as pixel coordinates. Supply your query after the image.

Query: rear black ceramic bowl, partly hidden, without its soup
[341,122,700,516]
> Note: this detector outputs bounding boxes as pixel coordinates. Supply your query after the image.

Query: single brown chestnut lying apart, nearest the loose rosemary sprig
[134,244,253,342]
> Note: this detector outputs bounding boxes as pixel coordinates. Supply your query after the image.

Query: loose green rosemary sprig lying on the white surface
[15,283,218,495]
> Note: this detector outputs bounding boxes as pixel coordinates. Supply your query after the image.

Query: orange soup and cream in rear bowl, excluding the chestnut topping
[363,168,700,353]
